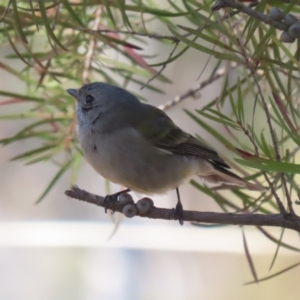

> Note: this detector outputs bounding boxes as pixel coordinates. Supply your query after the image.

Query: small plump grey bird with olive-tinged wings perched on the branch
[66,82,265,220]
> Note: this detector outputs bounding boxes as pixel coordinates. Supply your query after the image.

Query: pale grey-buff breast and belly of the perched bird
[78,128,204,194]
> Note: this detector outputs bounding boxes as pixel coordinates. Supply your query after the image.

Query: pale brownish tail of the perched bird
[201,164,266,192]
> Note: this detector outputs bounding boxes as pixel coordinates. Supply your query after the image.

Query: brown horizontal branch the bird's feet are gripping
[65,186,300,232]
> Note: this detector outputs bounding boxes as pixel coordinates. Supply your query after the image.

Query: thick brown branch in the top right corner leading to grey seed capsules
[212,0,289,31]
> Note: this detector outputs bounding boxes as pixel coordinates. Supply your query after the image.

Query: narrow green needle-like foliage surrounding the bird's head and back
[0,0,300,282]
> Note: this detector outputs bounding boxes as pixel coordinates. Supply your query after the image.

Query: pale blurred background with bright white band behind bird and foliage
[0,2,300,300]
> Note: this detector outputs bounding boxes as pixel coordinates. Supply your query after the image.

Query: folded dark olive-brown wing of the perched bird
[137,104,230,168]
